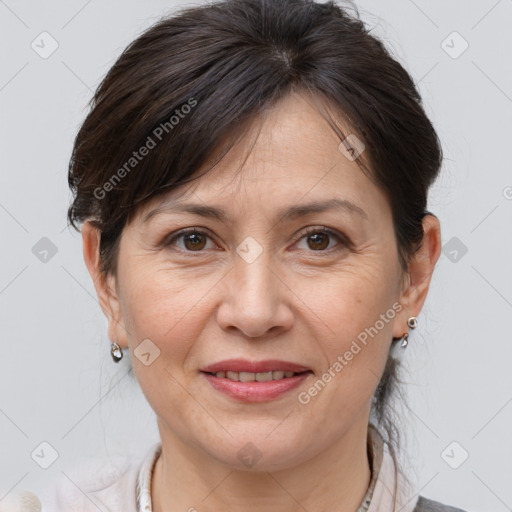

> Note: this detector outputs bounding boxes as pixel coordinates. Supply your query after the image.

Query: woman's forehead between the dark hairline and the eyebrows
[136,94,387,225]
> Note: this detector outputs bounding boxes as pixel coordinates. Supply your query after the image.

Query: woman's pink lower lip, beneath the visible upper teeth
[201,372,312,402]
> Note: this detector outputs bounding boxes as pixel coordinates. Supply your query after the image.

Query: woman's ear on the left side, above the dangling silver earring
[82,221,128,348]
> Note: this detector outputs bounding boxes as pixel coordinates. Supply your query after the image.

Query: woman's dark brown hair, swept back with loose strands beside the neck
[68,0,442,488]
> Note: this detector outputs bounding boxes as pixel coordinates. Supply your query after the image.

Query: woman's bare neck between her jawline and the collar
[151,424,371,512]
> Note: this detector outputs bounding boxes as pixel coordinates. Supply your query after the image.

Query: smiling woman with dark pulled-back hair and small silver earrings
[45,0,468,512]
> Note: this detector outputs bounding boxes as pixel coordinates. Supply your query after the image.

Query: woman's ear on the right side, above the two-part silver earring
[393,214,441,338]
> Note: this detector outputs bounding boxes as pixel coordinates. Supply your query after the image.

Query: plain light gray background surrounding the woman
[0,0,512,512]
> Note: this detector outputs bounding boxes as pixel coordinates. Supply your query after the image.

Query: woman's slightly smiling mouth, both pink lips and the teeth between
[201,359,313,402]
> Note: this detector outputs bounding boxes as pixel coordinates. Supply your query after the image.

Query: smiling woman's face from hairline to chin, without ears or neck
[85,95,436,470]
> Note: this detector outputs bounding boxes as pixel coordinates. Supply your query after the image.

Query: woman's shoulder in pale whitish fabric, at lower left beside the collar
[43,450,140,512]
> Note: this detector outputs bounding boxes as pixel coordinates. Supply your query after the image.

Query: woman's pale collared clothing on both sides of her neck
[43,425,464,512]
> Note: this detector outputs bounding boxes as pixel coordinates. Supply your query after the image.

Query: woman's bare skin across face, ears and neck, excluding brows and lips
[82,93,441,512]
